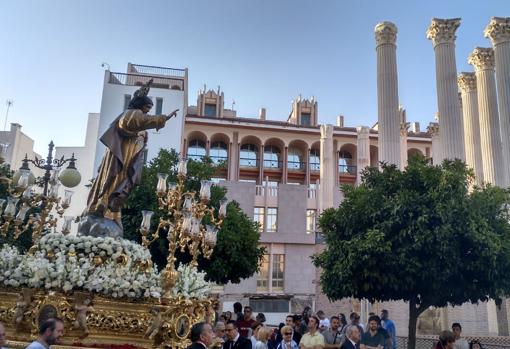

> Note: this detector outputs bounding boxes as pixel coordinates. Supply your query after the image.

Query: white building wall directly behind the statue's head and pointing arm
[94,71,185,173]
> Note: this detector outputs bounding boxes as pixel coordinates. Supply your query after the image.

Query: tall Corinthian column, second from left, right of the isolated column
[427,18,465,160]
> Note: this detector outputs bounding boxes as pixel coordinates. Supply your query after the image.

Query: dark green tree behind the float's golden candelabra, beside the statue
[122,149,264,283]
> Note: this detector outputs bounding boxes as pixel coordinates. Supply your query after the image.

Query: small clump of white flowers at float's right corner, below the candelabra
[172,264,214,299]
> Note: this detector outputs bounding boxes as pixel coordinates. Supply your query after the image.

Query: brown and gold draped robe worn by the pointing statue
[87,109,167,226]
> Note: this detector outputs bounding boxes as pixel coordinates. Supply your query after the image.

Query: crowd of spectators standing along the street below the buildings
[190,303,483,349]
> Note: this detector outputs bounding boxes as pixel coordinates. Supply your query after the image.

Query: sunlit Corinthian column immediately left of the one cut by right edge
[468,47,504,186]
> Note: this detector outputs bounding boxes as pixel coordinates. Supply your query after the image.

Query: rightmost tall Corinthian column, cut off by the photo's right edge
[484,17,510,186]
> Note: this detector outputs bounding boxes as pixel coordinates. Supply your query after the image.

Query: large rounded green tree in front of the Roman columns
[314,157,510,349]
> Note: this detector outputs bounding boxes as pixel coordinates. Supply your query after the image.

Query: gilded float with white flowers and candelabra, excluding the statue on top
[0,160,223,348]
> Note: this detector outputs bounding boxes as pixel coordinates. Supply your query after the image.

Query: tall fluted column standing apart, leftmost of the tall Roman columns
[375,22,400,167]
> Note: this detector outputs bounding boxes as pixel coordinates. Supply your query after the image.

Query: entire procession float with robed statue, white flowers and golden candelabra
[0,81,226,348]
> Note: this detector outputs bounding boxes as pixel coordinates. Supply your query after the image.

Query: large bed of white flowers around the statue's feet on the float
[0,233,161,298]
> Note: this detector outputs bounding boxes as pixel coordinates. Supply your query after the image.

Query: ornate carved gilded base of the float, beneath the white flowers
[0,289,213,349]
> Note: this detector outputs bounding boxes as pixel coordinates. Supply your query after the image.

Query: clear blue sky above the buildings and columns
[0,0,510,155]
